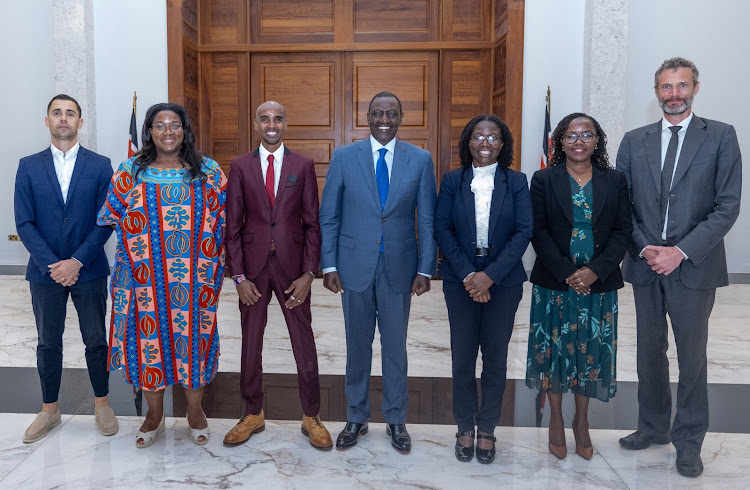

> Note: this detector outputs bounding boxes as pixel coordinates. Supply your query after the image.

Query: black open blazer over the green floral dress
[531,163,633,293]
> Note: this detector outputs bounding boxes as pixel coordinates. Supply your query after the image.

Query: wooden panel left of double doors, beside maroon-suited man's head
[200,53,250,172]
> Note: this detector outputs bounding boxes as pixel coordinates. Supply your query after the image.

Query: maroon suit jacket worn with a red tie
[226,146,320,280]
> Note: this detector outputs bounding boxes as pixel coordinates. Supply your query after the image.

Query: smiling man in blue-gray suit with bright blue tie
[320,92,437,452]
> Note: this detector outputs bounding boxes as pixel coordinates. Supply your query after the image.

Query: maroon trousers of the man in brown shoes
[240,252,320,417]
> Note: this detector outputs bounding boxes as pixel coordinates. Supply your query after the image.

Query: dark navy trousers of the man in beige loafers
[29,276,109,403]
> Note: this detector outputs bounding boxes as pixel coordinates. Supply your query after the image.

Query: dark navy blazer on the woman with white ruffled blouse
[435,167,534,287]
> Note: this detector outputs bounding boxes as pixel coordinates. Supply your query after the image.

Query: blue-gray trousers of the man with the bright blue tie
[341,254,411,424]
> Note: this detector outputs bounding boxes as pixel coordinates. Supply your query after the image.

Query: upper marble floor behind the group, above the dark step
[0,276,750,384]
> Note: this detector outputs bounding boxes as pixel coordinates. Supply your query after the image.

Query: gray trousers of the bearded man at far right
[633,269,716,452]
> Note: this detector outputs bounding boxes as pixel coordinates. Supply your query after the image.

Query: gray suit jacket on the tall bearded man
[617,116,742,289]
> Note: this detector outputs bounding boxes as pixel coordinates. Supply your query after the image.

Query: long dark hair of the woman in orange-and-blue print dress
[133,102,206,180]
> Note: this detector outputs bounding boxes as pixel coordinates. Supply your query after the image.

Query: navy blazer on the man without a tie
[14,146,113,283]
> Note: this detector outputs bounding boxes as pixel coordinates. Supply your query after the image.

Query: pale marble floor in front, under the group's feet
[0,414,750,490]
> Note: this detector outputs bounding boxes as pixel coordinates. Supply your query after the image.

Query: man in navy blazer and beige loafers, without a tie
[15,94,118,443]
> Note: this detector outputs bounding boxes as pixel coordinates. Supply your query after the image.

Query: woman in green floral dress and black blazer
[526,113,632,459]
